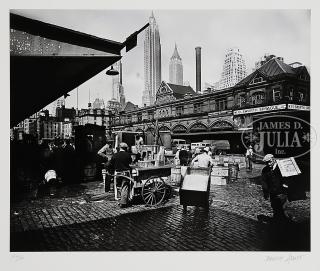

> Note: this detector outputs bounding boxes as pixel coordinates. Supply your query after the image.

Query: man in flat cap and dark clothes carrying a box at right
[261,154,288,222]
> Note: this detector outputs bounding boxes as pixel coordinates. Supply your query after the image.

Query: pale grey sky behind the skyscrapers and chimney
[12,9,311,108]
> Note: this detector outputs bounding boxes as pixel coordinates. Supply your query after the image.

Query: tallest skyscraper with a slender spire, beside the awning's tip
[142,12,161,105]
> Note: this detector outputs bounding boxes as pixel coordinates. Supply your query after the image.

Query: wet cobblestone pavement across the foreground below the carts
[10,168,310,251]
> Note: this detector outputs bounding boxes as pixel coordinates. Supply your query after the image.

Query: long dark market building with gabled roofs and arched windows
[112,58,310,157]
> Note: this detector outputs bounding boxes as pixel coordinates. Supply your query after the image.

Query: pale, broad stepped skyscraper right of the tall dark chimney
[219,48,247,89]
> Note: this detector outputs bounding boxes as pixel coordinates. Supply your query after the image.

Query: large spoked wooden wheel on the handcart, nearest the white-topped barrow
[141,177,166,205]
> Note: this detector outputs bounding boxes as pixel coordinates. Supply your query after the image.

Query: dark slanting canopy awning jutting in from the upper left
[10,13,148,127]
